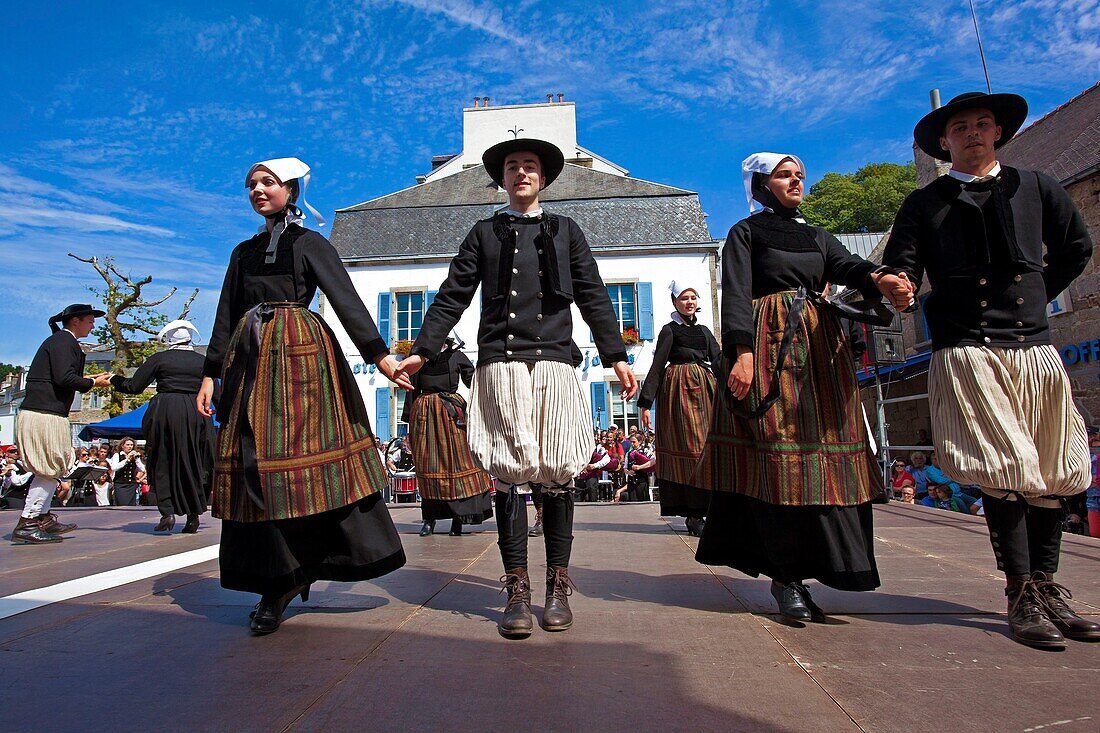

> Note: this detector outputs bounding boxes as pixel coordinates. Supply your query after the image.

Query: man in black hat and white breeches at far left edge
[11,303,111,545]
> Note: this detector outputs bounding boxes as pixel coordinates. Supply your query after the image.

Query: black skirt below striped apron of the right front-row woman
[699,491,879,591]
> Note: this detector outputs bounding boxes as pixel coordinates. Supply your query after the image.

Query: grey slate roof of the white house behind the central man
[332,164,714,259]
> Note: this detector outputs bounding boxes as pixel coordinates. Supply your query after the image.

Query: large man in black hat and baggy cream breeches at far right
[883,92,1100,649]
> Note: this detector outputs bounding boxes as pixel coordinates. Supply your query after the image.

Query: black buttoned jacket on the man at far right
[882,166,1092,349]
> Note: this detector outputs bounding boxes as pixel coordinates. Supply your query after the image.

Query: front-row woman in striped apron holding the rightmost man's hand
[695,153,911,621]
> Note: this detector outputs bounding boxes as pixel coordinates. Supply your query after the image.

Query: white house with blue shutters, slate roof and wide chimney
[320,96,719,439]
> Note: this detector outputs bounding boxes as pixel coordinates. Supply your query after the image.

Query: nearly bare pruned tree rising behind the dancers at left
[69,252,199,416]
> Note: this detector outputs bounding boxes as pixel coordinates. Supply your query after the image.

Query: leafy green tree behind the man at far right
[802,163,916,234]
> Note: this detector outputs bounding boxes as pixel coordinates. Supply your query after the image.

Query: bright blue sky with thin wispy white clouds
[0,0,1100,363]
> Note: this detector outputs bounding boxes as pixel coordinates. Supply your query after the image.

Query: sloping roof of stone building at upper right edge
[997,83,1100,185]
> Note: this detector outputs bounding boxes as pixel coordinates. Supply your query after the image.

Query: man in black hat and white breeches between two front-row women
[398,138,637,637]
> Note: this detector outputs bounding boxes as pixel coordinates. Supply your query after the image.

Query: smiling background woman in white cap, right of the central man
[638,281,722,530]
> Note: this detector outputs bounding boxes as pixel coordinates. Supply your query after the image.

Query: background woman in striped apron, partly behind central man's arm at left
[402,335,493,537]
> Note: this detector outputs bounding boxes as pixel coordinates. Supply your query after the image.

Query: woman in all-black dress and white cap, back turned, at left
[111,320,215,534]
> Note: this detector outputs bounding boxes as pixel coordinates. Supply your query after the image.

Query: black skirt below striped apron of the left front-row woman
[219,493,405,594]
